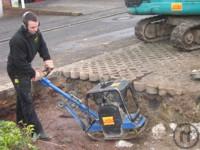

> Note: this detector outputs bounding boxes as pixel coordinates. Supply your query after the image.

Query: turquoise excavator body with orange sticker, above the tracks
[125,0,200,15]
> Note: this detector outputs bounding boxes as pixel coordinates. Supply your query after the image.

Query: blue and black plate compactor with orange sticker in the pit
[40,77,147,140]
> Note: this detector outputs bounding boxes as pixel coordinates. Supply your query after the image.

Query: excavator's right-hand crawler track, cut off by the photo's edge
[170,22,200,51]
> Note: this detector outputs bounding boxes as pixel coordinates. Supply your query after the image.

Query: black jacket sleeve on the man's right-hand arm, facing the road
[38,33,51,61]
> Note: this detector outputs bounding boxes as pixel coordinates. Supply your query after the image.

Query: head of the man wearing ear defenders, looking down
[22,11,40,34]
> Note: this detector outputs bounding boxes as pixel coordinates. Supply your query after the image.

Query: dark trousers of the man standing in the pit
[8,72,43,133]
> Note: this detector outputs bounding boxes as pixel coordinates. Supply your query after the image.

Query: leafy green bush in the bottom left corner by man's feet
[0,121,37,150]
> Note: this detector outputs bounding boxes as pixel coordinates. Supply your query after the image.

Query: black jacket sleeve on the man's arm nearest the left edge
[9,38,35,78]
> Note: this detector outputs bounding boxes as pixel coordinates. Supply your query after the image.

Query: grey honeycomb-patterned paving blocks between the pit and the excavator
[54,42,200,95]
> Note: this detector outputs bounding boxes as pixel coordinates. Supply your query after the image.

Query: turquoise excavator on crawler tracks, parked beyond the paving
[125,0,200,51]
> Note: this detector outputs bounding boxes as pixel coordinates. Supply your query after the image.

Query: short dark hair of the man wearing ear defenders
[22,11,39,26]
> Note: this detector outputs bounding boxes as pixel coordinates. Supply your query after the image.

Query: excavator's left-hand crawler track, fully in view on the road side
[135,16,174,42]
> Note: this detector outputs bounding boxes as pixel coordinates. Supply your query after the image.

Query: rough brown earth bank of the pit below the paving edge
[0,78,200,125]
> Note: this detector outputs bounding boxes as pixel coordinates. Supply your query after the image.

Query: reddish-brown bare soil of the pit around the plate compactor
[0,79,200,150]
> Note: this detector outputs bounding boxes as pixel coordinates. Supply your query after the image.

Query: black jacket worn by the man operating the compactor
[7,26,50,78]
